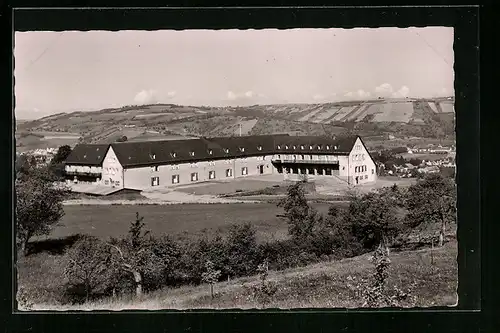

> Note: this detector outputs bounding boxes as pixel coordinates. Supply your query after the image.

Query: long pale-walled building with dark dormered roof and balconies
[65,135,377,190]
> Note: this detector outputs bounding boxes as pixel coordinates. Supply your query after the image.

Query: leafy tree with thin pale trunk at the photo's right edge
[407,173,457,246]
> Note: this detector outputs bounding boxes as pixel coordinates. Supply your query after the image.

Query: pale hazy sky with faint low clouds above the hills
[14,27,454,119]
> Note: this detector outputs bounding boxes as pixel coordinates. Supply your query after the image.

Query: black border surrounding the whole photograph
[0,2,491,332]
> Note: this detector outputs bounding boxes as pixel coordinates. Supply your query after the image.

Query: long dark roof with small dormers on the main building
[66,134,357,167]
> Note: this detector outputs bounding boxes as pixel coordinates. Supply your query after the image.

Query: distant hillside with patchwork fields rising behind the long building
[16,97,455,146]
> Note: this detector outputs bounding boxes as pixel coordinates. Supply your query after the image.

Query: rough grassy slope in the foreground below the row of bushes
[23,236,458,310]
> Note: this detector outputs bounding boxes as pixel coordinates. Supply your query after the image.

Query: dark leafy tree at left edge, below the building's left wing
[15,176,67,255]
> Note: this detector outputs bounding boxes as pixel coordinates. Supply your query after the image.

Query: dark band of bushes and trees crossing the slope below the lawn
[59,175,456,302]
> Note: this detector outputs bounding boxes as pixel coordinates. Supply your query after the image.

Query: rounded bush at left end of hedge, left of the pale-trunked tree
[64,235,111,301]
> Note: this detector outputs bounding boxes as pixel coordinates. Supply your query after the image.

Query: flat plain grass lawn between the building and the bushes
[48,203,329,240]
